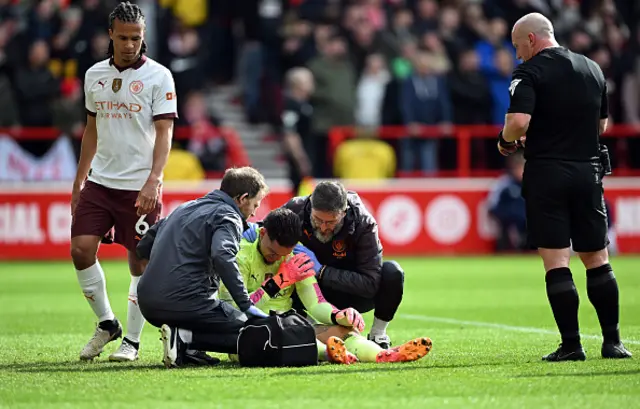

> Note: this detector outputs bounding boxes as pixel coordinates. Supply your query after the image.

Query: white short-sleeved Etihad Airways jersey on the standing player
[84,56,178,191]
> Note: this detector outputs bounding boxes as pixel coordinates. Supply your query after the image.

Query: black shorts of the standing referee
[522,159,609,252]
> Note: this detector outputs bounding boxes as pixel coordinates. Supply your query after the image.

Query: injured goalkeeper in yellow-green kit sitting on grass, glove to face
[220,208,431,364]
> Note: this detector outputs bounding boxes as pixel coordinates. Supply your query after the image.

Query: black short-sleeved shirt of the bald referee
[508,47,608,162]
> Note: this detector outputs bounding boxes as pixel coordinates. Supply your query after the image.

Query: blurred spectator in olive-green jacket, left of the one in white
[309,36,356,178]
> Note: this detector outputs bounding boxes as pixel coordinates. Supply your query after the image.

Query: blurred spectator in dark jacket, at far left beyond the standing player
[15,40,60,127]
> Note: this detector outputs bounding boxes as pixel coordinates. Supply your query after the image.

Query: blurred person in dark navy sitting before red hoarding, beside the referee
[487,151,527,251]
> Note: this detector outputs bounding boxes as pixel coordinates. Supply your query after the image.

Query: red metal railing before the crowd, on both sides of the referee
[328,125,640,177]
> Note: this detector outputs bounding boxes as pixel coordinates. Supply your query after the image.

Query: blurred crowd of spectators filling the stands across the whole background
[0,0,640,250]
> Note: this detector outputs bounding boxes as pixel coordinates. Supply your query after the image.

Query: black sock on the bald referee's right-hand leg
[587,263,620,344]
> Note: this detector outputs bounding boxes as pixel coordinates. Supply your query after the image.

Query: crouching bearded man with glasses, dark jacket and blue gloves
[244,181,404,349]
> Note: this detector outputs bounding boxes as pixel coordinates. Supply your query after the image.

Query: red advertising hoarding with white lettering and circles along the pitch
[0,178,640,260]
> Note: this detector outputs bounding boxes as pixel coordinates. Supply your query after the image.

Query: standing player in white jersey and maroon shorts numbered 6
[71,1,178,361]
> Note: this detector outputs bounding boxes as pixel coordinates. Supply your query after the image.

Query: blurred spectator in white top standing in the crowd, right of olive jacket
[355,54,390,128]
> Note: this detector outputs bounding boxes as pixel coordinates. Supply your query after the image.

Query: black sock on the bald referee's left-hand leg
[545,267,580,348]
